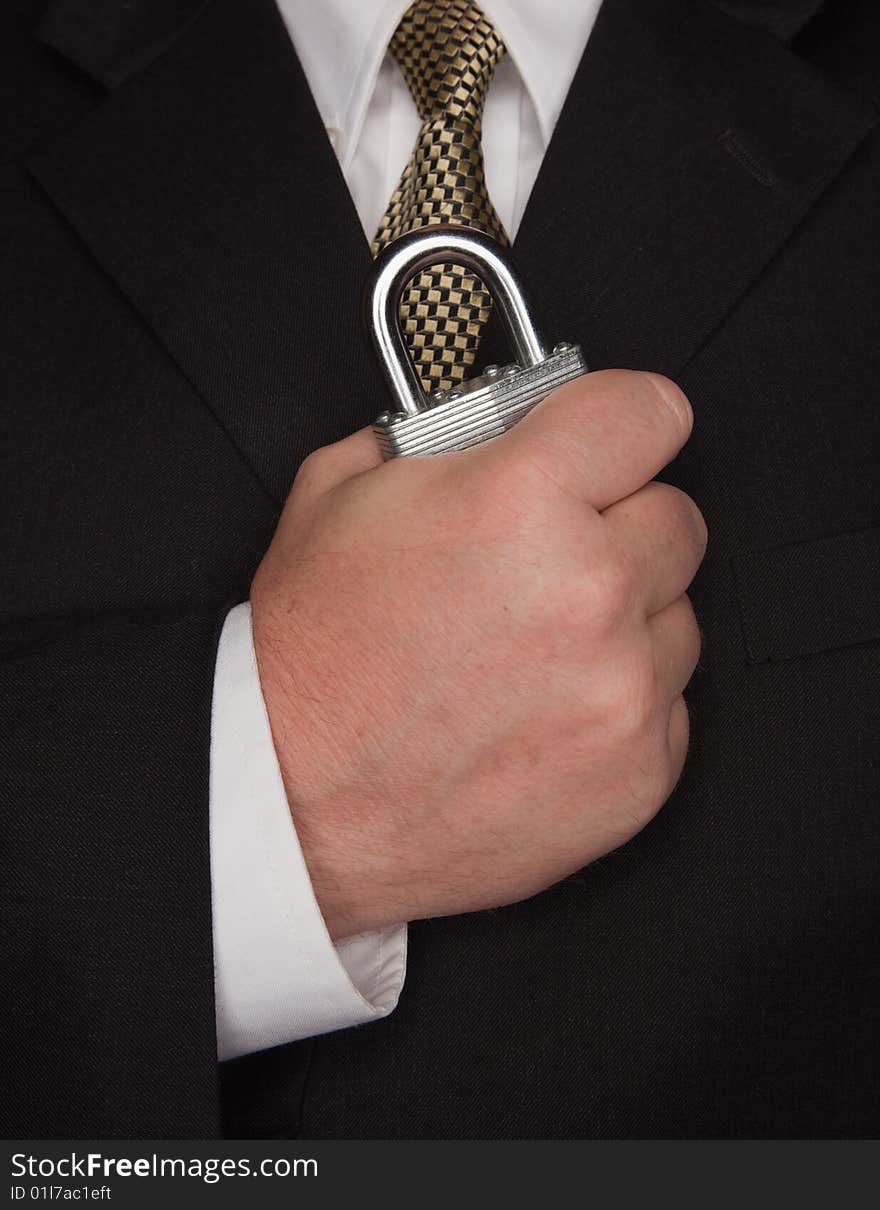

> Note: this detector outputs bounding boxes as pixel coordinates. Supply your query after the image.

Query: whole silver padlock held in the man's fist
[364,224,587,460]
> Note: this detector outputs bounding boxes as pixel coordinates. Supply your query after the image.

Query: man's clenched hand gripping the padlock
[252,370,706,938]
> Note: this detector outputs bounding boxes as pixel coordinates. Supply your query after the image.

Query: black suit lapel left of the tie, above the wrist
[29,0,381,500]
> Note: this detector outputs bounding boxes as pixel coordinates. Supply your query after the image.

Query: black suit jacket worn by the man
[0,0,880,1137]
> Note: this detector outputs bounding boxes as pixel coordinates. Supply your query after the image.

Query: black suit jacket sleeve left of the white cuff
[0,606,228,1139]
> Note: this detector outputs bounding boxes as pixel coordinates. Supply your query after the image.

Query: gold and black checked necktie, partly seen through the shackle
[373,0,507,391]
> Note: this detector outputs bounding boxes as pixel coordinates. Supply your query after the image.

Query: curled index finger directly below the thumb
[602,482,707,615]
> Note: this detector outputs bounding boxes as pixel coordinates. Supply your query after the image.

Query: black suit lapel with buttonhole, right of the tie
[514,0,876,374]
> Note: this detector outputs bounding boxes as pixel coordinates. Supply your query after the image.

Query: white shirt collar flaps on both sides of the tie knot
[277,0,602,163]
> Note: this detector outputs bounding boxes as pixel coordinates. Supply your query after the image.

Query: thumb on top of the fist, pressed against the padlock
[498,370,692,508]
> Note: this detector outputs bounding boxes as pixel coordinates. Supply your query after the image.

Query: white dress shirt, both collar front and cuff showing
[211,0,602,1059]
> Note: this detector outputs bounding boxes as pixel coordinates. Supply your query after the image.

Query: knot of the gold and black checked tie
[389,0,505,127]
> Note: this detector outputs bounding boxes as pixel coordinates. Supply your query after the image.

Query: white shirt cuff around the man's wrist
[211,603,407,1060]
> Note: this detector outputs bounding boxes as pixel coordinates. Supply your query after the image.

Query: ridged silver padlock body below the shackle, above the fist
[373,345,587,461]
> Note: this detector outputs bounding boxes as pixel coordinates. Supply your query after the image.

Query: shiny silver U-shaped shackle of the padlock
[364,224,547,416]
